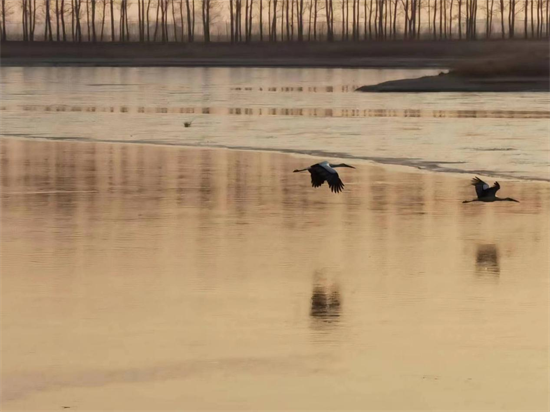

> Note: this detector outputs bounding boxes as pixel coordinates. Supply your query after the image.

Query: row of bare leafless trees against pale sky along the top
[0,0,550,43]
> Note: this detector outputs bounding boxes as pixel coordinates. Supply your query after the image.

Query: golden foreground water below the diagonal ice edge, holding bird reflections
[0,138,550,412]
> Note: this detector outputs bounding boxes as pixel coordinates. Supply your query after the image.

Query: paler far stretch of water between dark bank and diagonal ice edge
[0,68,550,180]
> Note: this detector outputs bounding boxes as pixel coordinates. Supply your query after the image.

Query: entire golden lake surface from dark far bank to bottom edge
[0,68,550,412]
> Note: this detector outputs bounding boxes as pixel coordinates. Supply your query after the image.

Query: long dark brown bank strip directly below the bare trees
[0,40,547,68]
